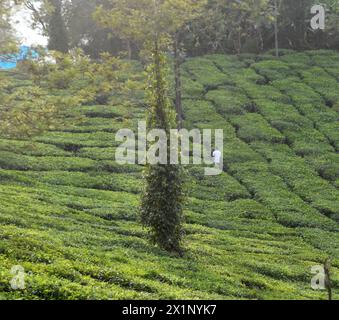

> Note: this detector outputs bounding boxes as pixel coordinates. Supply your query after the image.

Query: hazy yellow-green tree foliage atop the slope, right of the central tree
[186,0,272,55]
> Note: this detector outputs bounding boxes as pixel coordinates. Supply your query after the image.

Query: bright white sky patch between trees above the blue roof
[12,7,47,46]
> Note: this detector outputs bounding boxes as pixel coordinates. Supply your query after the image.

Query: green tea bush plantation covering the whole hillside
[0,51,339,299]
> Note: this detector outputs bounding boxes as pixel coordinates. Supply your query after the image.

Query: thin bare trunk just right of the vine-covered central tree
[174,35,183,129]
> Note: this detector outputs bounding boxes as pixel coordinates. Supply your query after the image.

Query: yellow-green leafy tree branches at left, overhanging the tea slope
[0,49,133,139]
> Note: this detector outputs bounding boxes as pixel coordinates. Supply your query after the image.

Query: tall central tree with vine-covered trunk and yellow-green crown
[96,0,205,253]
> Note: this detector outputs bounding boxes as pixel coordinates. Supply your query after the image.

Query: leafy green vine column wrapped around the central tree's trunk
[140,51,184,253]
